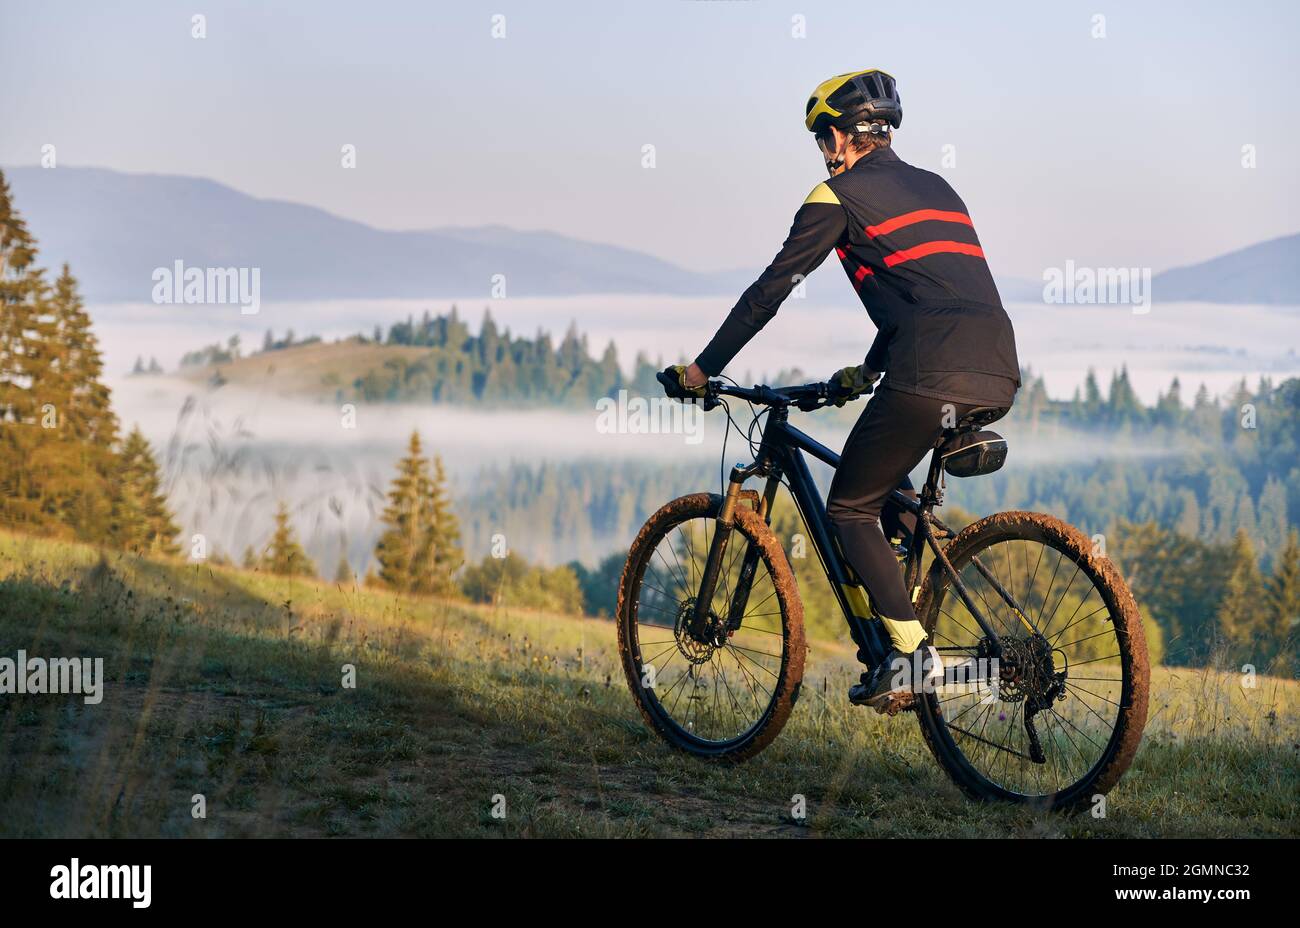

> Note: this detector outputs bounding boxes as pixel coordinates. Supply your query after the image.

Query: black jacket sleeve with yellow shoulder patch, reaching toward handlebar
[696,191,848,377]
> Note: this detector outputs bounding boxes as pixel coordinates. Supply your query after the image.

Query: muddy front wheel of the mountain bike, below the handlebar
[616,493,806,760]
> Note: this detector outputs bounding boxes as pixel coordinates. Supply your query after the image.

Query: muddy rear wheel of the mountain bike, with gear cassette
[917,512,1151,808]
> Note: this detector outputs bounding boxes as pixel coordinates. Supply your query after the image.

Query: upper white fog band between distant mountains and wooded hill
[92,295,1300,403]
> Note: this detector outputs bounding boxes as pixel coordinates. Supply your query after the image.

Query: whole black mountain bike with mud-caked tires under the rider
[616,374,1149,808]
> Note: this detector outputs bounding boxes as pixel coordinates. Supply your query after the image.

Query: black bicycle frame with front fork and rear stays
[692,394,1037,665]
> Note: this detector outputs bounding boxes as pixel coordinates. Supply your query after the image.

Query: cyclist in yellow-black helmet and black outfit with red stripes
[673,69,1021,712]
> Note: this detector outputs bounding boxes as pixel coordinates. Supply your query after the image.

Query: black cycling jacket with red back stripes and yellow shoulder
[696,148,1021,406]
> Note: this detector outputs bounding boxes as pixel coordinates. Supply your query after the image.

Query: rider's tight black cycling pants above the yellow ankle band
[827,387,975,621]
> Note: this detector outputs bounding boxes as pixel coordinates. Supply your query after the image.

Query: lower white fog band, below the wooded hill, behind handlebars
[113,377,1185,574]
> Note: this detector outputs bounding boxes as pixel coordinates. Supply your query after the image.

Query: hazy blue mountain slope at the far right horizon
[1151,234,1300,304]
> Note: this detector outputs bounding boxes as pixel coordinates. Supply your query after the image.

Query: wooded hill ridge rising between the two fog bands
[175,305,1300,418]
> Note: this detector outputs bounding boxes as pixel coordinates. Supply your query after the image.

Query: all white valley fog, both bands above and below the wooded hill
[91,296,1300,574]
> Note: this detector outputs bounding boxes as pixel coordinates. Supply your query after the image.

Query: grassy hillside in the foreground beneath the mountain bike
[0,532,1300,837]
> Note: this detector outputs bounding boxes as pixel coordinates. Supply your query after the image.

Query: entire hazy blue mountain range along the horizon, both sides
[5,166,1300,304]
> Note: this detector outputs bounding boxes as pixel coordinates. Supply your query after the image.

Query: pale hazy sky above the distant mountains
[0,0,1300,278]
